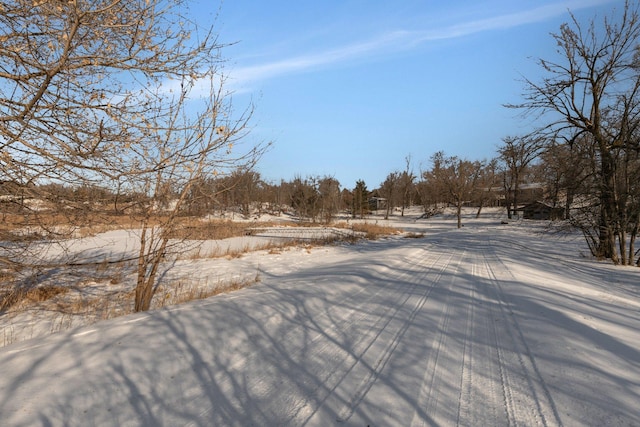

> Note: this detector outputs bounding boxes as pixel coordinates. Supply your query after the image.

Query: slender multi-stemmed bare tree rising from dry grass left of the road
[124,80,260,311]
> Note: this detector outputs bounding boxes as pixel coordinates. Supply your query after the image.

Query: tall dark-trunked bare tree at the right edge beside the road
[515,1,640,264]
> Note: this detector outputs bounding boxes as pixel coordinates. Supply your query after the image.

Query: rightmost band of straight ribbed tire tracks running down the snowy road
[411,237,561,427]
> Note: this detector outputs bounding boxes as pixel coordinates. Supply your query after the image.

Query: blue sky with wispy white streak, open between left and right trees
[191,0,624,189]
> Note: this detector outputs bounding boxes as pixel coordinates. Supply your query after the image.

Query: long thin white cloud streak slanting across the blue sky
[229,0,614,87]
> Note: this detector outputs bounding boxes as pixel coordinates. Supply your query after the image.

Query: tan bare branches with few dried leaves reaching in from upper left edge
[0,0,219,261]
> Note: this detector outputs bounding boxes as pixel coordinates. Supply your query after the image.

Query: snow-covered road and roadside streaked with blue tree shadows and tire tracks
[0,209,640,426]
